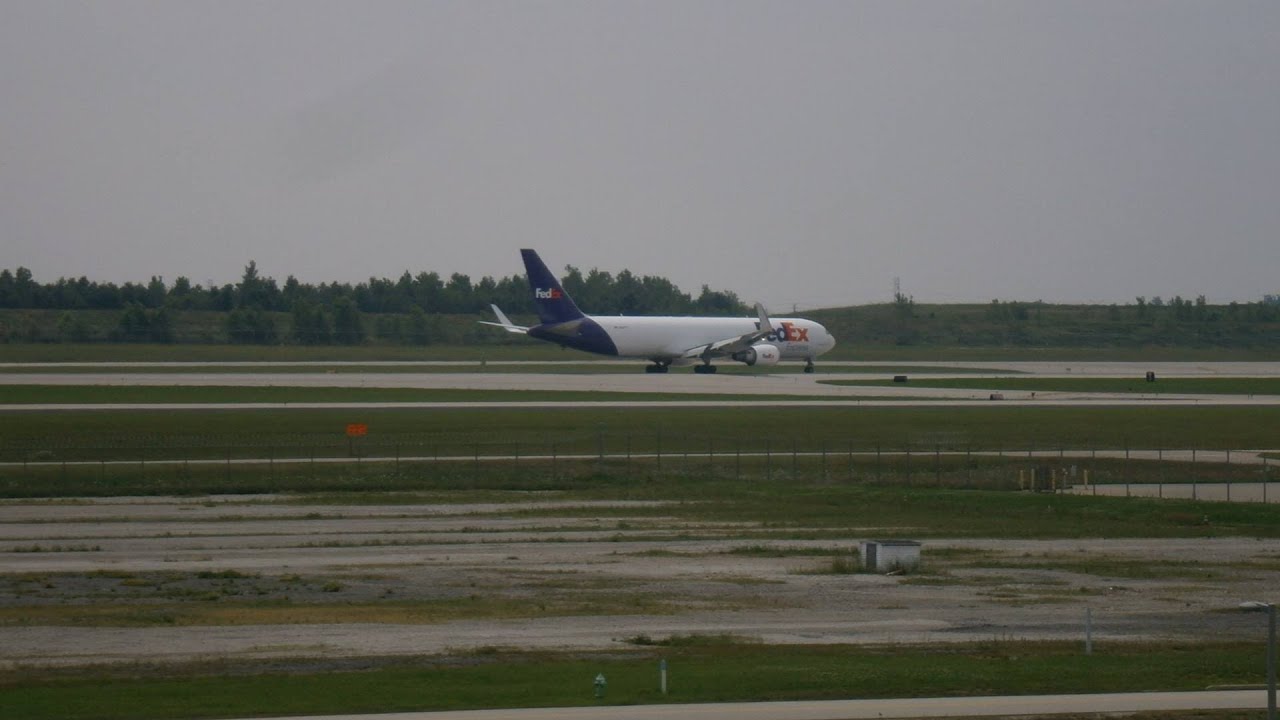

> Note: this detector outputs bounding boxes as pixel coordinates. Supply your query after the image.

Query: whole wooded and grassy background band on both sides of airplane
[0,261,1280,347]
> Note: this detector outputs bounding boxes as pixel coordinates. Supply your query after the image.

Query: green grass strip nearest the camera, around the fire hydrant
[0,637,1263,720]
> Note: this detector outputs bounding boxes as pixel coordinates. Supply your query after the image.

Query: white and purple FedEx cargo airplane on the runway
[480,249,836,374]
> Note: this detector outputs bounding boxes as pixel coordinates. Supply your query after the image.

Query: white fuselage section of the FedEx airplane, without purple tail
[590,315,836,360]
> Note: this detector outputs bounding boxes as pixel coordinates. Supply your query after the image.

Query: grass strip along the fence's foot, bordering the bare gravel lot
[0,454,1280,532]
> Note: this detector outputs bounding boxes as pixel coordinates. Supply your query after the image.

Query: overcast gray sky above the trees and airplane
[0,0,1280,304]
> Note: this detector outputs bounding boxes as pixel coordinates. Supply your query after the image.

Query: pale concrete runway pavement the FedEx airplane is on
[0,361,1280,411]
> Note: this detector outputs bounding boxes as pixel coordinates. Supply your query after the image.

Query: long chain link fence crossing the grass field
[0,427,1280,502]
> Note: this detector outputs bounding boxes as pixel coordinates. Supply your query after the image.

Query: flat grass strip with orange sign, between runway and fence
[0,405,1280,460]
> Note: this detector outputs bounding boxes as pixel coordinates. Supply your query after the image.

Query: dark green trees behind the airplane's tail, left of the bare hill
[0,260,749,345]
